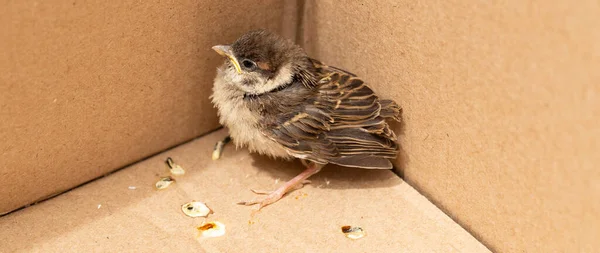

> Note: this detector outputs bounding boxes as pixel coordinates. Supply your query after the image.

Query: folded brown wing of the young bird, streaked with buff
[264,60,401,169]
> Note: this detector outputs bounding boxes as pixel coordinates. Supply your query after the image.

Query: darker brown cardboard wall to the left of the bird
[0,0,284,213]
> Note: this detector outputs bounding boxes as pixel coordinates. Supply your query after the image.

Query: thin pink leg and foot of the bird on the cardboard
[238,162,325,210]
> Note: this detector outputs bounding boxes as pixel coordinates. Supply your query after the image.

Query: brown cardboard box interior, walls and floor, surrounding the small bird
[0,0,600,252]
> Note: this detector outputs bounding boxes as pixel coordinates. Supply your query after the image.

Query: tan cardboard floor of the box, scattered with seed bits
[0,131,489,252]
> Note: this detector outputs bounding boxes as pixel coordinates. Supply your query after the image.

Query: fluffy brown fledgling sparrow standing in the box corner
[211,30,402,210]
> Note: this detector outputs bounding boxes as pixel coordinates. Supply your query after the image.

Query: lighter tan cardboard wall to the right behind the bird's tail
[304,0,600,252]
